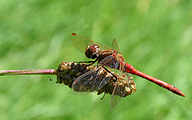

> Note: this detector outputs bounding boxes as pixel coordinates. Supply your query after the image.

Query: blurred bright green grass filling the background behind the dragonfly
[0,0,192,120]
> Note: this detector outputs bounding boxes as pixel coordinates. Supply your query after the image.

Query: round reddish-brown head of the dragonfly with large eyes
[85,44,100,59]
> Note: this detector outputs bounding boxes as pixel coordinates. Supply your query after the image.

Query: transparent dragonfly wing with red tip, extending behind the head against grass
[69,33,111,53]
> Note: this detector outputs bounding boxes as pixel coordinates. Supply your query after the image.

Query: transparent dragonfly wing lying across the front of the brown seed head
[72,67,111,93]
